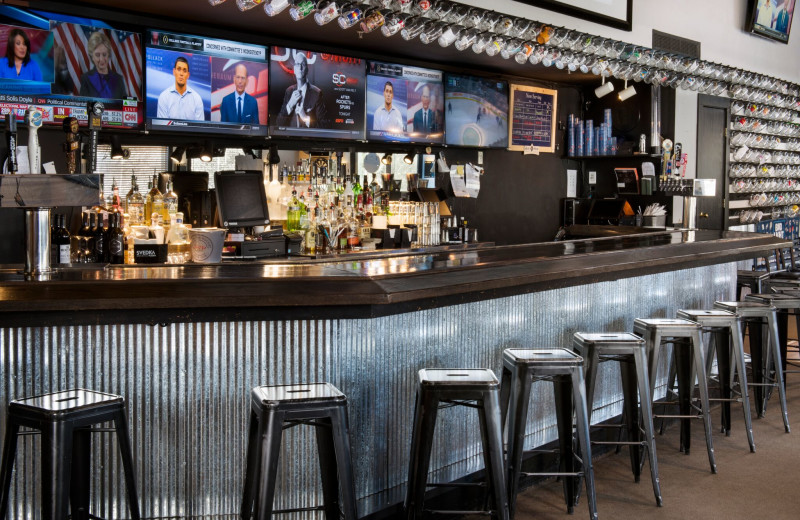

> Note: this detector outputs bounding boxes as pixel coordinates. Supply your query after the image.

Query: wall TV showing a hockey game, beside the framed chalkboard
[444,74,508,148]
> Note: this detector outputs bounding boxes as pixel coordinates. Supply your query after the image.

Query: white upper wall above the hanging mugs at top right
[459,0,800,83]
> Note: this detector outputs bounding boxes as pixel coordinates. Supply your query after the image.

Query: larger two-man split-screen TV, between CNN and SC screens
[145,31,269,137]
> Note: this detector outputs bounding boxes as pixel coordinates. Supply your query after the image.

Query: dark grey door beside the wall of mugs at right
[696,94,730,229]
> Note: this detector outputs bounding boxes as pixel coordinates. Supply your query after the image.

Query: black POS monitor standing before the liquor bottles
[214,170,269,228]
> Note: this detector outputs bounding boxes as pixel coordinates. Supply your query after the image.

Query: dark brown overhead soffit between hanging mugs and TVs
[61,0,597,84]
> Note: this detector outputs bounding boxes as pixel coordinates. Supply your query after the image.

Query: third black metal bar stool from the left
[405,368,508,520]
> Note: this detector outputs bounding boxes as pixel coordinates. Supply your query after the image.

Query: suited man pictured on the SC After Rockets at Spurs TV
[277,52,328,128]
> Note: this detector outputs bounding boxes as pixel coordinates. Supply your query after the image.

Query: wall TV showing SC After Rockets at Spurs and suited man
[269,47,364,139]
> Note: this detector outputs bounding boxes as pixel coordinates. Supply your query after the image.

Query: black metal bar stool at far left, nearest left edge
[0,388,139,520]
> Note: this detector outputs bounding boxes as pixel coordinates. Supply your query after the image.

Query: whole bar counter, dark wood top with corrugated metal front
[0,231,789,519]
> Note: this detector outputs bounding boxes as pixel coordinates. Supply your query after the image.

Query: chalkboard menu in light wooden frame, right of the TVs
[508,85,558,153]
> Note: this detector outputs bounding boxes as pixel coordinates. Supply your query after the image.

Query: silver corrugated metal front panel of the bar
[0,263,736,519]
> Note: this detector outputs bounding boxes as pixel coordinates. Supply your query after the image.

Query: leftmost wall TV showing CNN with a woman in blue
[0,6,143,129]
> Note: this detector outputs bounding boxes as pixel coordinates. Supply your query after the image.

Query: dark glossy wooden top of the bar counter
[0,230,790,325]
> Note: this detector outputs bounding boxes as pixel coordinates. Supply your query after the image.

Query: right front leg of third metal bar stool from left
[479,391,509,520]
